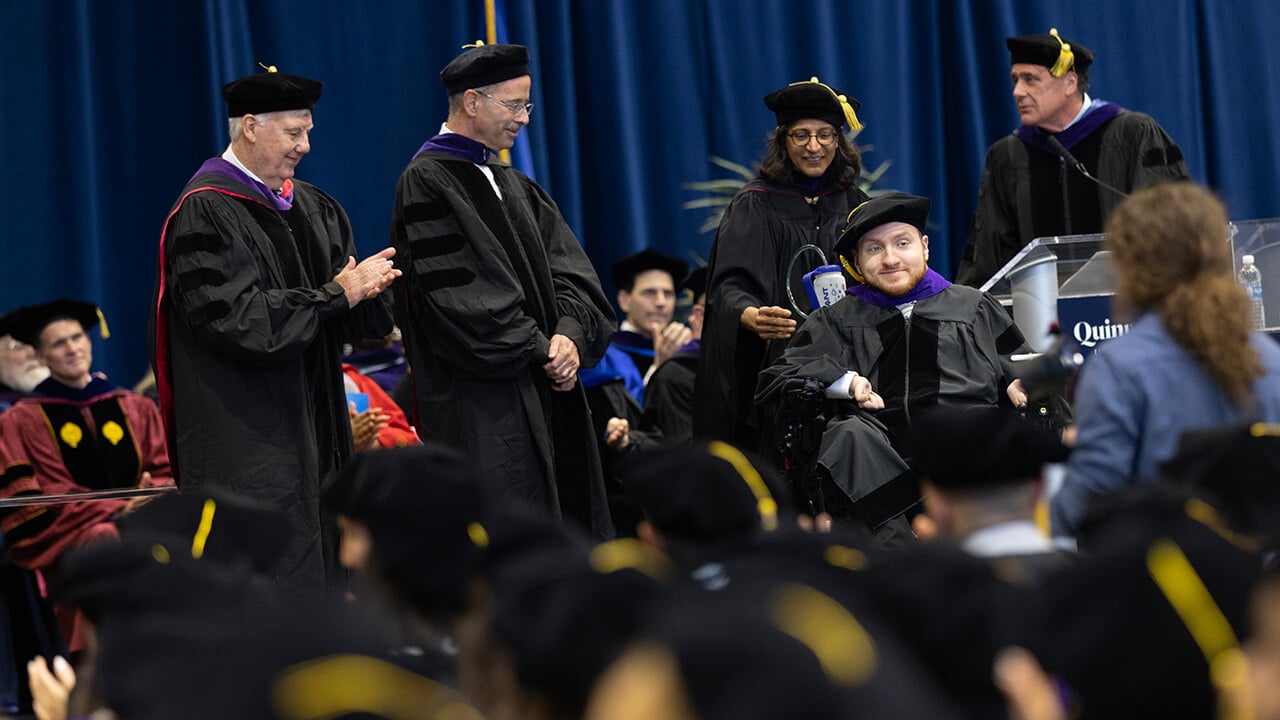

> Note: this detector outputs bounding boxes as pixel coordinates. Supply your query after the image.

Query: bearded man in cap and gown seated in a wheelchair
[755,192,1027,546]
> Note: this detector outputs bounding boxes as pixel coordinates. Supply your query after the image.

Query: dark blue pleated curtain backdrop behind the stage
[0,0,1280,383]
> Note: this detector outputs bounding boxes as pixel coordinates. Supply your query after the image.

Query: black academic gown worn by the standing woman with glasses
[694,178,867,450]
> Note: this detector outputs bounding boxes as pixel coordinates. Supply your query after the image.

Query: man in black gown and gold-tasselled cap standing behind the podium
[956,29,1188,287]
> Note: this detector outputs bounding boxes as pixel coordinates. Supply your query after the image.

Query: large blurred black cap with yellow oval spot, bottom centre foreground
[593,569,957,720]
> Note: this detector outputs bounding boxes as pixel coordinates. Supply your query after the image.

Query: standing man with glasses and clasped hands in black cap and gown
[392,44,616,538]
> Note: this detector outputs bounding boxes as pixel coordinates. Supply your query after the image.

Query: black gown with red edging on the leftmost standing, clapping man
[152,173,392,593]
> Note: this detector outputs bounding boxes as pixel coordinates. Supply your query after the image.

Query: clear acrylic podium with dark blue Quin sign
[982,218,1280,355]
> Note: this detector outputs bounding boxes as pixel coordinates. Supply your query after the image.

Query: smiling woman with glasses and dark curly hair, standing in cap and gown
[694,78,867,452]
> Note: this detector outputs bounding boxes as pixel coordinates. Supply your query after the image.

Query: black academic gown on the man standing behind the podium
[956,110,1188,287]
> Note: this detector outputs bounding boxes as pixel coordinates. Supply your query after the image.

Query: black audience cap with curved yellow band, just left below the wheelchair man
[620,442,778,543]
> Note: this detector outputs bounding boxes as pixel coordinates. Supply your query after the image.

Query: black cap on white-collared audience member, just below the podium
[911,407,1068,489]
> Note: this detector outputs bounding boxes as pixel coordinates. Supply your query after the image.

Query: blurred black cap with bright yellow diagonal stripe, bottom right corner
[1023,519,1261,719]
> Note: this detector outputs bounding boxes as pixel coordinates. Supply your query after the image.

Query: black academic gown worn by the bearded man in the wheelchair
[756,284,1023,527]
